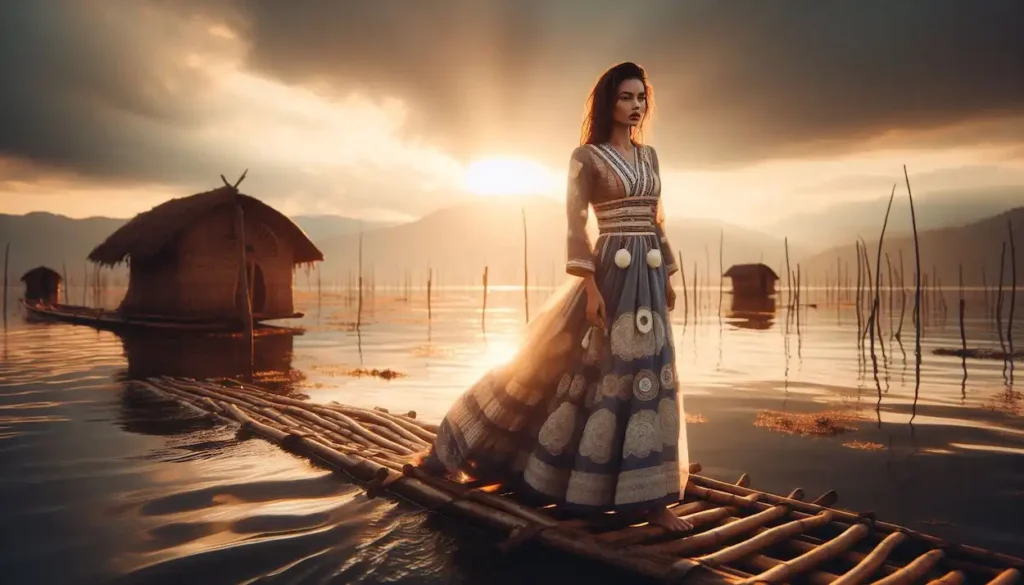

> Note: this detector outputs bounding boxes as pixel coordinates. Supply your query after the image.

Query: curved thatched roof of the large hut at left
[89,185,324,266]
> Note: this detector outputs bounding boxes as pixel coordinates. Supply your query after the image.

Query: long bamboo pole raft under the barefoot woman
[136,377,1024,585]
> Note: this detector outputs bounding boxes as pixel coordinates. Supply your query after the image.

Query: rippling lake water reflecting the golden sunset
[0,282,1024,584]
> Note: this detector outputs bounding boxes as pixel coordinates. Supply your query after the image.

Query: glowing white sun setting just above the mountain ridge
[462,157,560,197]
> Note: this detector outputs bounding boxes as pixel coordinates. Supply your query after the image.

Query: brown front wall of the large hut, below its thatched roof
[168,207,294,318]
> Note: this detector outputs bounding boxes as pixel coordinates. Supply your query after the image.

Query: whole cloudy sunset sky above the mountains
[0,0,1024,226]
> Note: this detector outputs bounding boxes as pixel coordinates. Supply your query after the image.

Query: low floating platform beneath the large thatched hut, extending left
[22,299,303,334]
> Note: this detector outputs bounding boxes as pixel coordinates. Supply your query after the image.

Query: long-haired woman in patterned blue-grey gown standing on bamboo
[422,62,692,531]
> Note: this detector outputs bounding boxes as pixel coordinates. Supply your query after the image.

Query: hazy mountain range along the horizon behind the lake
[0,194,1024,286]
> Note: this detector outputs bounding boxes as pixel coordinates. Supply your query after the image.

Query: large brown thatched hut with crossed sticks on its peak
[89,185,324,321]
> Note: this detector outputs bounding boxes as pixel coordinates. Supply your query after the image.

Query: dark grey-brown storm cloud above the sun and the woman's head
[203,0,1024,163]
